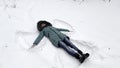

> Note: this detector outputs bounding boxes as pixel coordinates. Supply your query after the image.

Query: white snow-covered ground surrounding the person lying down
[0,0,120,68]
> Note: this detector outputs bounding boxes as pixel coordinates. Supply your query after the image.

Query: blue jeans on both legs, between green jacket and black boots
[58,38,80,59]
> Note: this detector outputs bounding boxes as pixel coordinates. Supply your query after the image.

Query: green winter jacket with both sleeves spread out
[33,26,69,47]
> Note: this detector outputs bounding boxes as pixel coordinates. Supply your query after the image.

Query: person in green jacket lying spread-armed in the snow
[31,21,89,63]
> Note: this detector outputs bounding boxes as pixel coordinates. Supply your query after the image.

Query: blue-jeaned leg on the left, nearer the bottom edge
[59,41,79,59]
